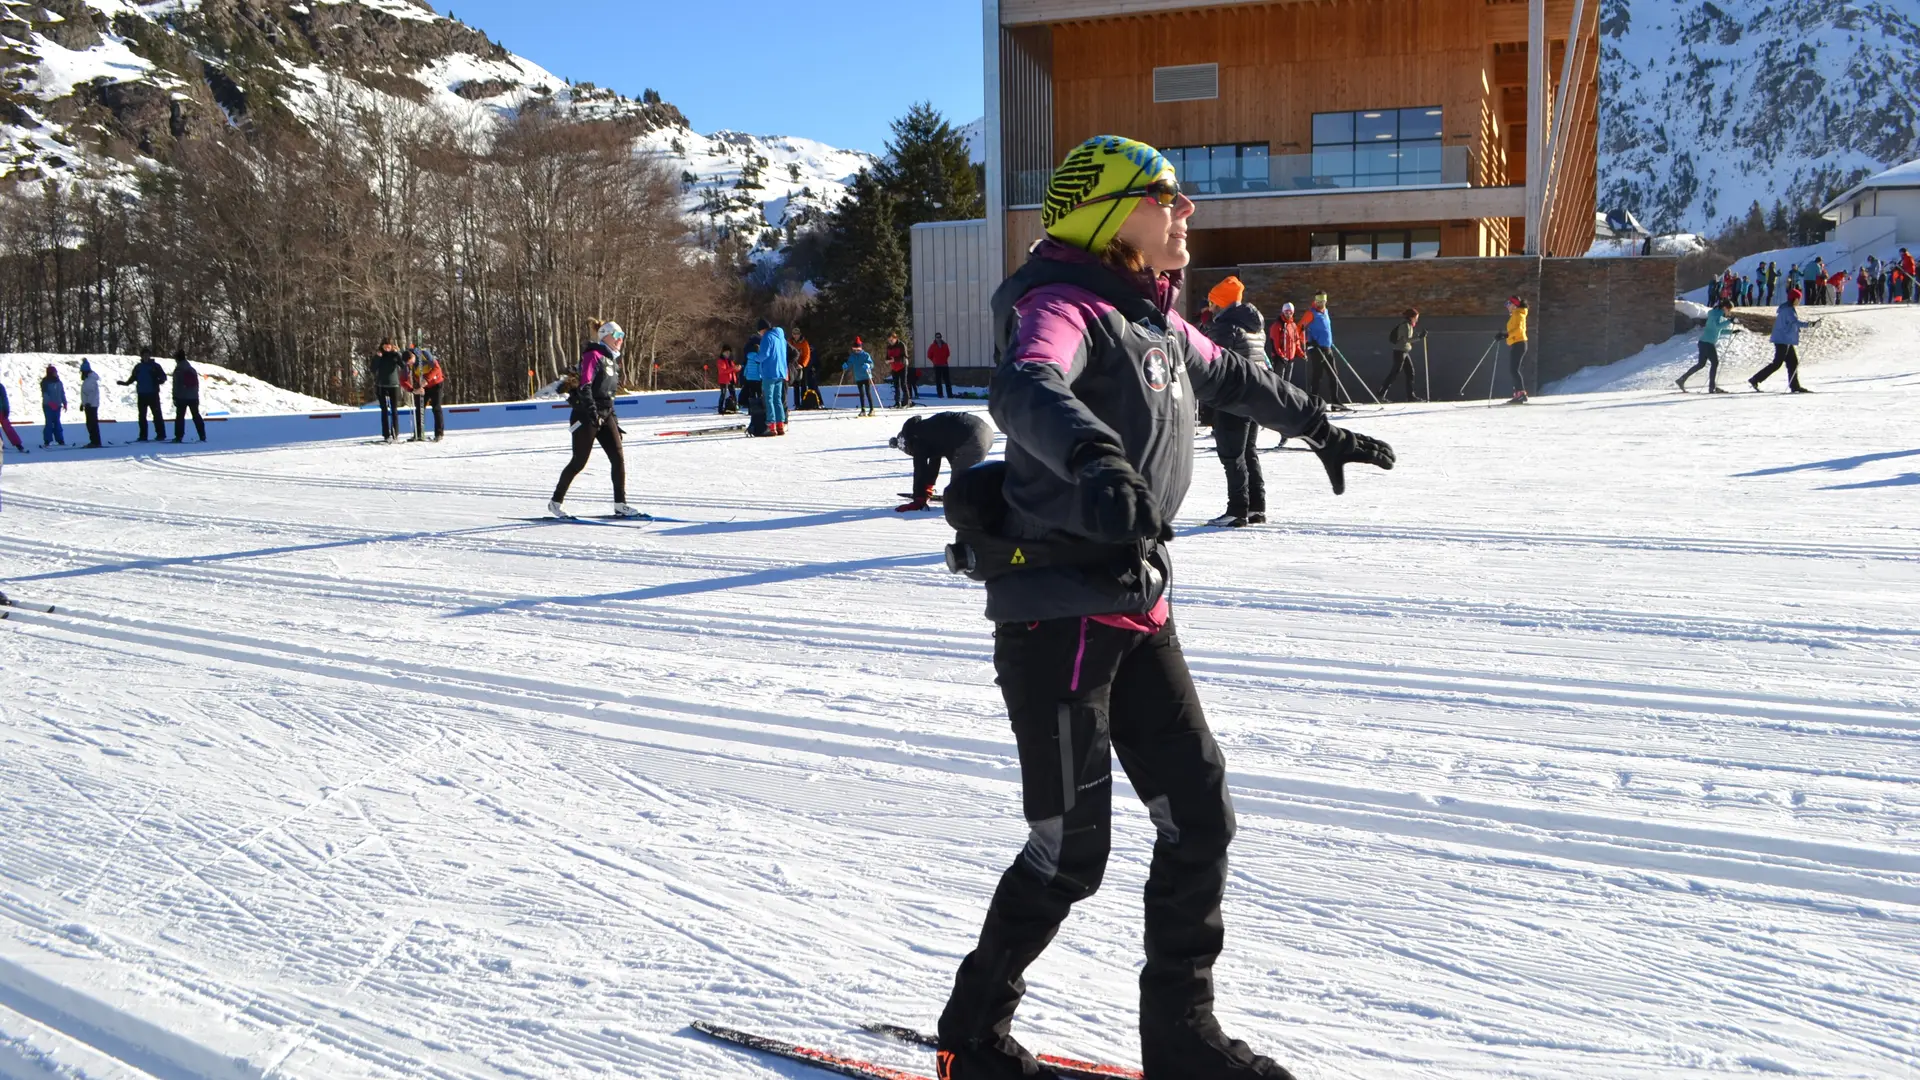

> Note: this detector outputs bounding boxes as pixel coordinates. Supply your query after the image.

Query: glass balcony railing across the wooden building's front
[1006,146,1473,209]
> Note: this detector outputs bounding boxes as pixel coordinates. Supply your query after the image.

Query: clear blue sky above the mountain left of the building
[434,0,985,154]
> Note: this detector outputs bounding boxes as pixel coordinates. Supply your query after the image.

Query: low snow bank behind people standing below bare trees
[0,352,340,423]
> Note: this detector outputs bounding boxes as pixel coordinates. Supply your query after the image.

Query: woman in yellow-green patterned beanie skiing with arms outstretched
[939,136,1394,1080]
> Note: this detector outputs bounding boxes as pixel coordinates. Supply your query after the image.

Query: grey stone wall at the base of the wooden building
[1187,258,1678,402]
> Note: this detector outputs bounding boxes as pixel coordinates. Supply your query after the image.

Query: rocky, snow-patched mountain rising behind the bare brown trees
[0,0,874,244]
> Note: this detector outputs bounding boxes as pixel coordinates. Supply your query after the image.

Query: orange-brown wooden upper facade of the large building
[983,0,1601,282]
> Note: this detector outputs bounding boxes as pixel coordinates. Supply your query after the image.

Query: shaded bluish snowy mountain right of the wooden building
[1599,0,1920,233]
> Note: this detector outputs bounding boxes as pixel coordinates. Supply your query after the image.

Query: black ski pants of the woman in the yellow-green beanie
[939,617,1235,1070]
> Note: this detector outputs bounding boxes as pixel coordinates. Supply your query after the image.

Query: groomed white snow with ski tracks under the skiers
[0,309,1920,1080]
